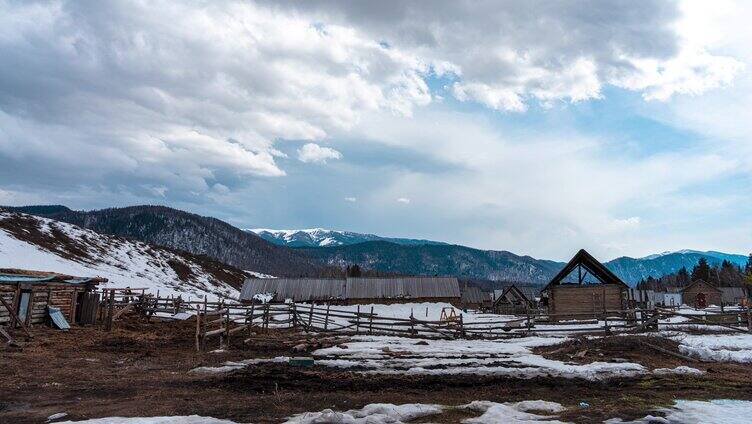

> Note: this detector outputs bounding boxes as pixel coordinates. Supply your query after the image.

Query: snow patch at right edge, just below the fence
[662,332,752,362]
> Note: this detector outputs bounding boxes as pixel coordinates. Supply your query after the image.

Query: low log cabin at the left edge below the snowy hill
[0,269,107,328]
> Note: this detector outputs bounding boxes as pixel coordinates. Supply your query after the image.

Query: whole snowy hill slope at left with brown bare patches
[0,211,246,299]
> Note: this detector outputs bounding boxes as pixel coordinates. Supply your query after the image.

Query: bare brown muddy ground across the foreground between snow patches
[0,317,752,423]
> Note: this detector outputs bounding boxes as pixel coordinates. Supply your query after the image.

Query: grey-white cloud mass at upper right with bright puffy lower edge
[280,0,741,112]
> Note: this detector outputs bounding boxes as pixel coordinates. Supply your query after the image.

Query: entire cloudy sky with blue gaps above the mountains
[0,0,752,260]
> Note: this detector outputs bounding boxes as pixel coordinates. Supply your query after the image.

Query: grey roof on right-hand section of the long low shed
[346,277,460,299]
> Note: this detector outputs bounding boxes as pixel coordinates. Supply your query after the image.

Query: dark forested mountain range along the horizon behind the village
[5,206,747,285]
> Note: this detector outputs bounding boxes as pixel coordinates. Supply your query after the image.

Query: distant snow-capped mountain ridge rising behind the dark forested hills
[246,228,447,247]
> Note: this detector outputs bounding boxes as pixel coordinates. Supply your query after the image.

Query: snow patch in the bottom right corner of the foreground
[606,399,752,424]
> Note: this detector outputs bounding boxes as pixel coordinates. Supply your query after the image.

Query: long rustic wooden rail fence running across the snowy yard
[128,296,752,350]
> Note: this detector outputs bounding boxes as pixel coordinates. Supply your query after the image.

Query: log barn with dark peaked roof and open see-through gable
[542,249,629,320]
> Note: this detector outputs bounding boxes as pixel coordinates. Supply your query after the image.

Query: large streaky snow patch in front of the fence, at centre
[313,336,647,380]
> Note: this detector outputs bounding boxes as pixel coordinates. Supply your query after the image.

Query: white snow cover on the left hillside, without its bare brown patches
[0,212,239,300]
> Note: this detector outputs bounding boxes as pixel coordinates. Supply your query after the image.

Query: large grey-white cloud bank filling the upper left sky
[0,1,431,196]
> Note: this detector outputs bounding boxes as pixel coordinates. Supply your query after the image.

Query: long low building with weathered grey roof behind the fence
[240,277,460,305]
